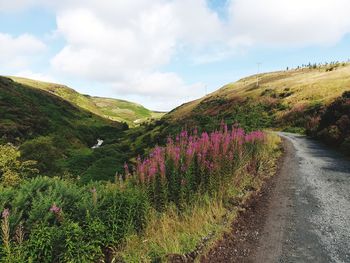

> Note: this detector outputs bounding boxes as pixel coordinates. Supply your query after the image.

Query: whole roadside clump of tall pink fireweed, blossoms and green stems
[128,125,265,210]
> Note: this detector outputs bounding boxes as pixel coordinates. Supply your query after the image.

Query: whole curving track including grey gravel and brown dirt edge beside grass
[201,133,350,263]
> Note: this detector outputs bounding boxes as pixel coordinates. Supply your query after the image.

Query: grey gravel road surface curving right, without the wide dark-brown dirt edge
[252,133,350,263]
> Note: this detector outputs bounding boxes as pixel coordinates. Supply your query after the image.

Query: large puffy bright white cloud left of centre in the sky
[52,6,175,81]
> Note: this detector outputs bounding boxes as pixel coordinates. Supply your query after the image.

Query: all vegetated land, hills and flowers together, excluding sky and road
[0,63,350,263]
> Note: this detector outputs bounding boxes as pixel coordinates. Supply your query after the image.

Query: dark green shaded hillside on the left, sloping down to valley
[0,77,123,145]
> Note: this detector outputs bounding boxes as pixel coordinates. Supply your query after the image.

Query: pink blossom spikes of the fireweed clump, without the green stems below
[124,126,264,196]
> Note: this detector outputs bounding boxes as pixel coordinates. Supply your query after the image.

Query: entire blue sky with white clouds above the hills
[0,0,350,111]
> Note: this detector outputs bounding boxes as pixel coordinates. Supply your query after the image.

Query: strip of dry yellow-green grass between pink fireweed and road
[115,134,281,262]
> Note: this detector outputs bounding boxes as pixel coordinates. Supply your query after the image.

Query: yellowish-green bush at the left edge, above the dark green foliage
[0,144,38,186]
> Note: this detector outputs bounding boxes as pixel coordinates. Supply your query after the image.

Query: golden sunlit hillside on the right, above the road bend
[163,63,350,131]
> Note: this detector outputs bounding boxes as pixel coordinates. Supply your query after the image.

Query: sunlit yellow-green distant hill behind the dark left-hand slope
[10,77,164,127]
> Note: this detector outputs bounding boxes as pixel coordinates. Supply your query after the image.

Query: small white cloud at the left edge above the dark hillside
[0,33,46,68]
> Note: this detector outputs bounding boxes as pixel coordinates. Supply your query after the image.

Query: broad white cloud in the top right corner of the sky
[229,0,350,47]
